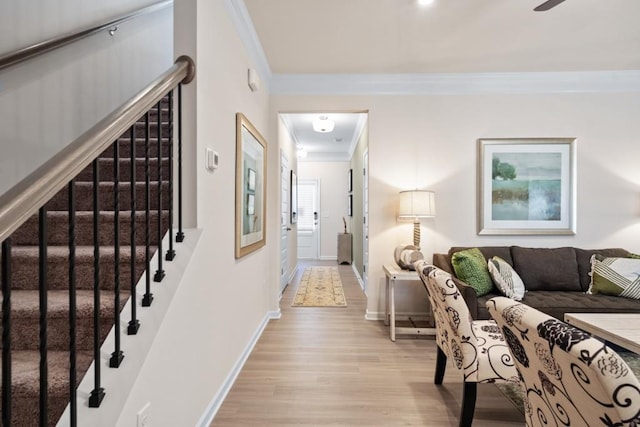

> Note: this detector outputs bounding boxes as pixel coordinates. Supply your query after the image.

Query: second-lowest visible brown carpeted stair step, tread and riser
[0,288,129,351]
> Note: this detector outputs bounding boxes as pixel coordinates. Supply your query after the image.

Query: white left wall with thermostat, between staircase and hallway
[117,0,280,426]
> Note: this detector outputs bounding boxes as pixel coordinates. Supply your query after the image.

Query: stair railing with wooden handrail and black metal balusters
[0,56,195,427]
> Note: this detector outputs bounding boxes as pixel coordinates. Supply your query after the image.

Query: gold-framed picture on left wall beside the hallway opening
[235,113,267,258]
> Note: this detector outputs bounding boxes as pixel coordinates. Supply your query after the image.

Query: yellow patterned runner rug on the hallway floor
[291,267,347,307]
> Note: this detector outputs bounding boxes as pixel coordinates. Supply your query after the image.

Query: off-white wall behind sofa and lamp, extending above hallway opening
[272,93,640,318]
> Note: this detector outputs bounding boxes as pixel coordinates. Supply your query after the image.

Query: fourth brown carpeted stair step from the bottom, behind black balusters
[11,211,169,246]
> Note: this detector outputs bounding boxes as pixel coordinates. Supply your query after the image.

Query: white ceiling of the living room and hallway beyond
[237,0,640,160]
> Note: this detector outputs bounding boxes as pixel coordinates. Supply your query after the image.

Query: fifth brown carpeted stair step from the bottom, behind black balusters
[46,181,169,211]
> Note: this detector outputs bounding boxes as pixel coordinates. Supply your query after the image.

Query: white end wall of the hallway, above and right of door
[298,161,350,260]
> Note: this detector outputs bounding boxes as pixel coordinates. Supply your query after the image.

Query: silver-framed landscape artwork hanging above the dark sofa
[478,138,576,235]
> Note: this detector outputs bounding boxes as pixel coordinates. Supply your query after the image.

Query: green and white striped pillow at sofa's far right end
[588,255,640,299]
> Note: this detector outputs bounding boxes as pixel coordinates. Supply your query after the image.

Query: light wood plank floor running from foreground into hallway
[211,262,524,427]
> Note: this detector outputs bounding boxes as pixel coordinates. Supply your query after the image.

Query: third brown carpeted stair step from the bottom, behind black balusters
[11,248,151,290]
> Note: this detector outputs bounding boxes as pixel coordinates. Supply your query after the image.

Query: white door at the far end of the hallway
[298,179,320,259]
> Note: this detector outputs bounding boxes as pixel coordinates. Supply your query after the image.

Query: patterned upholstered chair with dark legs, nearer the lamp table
[414,261,519,426]
